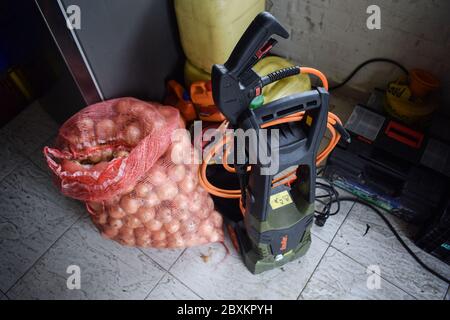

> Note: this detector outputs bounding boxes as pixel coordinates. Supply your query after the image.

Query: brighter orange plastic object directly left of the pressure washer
[191,81,225,122]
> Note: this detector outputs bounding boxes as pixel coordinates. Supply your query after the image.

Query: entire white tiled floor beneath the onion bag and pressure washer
[0,99,450,300]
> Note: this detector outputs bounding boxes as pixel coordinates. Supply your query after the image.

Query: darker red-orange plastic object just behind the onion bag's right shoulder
[164,80,197,122]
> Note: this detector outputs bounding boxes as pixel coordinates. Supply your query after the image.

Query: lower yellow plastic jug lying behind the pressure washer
[184,56,311,103]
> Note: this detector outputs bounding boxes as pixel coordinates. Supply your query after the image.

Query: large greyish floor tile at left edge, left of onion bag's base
[0,161,85,292]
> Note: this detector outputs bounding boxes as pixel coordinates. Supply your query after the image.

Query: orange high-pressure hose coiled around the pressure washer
[199,67,342,200]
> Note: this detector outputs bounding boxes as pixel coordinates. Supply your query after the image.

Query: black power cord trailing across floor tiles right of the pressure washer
[315,174,450,284]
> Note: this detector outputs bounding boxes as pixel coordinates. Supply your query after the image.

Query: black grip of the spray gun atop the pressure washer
[225,12,289,77]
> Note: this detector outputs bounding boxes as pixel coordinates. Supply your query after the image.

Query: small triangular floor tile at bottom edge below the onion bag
[146,274,200,300]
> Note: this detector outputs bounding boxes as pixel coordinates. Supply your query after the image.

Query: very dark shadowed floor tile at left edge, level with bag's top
[0,102,59,156]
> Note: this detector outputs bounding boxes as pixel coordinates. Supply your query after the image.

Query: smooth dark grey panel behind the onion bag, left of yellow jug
[62,0,184,100]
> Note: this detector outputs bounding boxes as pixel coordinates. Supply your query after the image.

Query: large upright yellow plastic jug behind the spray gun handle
[175,0,265,72]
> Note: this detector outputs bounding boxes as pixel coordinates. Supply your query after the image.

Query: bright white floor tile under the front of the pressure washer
[170,236,327,300]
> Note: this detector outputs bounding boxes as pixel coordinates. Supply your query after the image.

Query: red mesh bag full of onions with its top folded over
[44,98,223,248]
